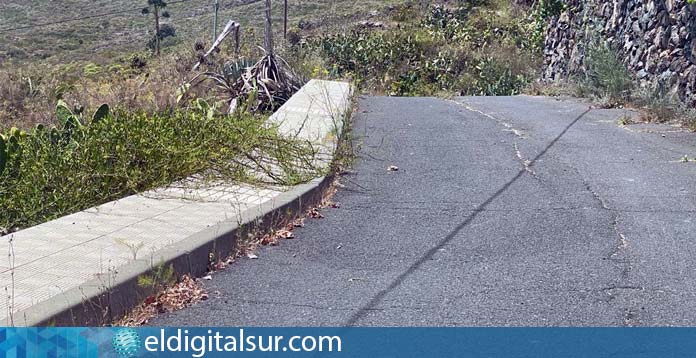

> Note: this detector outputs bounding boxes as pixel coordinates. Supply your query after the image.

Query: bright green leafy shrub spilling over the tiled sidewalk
[0,104,316,229]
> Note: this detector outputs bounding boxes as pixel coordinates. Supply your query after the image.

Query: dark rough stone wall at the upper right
[543,0,696,105]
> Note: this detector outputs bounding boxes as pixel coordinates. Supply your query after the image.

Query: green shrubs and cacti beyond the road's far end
[308,1,540,96]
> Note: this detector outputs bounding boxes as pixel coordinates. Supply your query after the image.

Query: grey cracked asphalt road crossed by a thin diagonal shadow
[151,96,696,326]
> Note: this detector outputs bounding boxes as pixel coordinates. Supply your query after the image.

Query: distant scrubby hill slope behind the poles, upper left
[0,0,392,66]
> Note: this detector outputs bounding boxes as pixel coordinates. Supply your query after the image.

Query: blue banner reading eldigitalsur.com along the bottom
[0,327,696,358]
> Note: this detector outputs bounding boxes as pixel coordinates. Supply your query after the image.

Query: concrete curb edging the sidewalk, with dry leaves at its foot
[0,176,333,326]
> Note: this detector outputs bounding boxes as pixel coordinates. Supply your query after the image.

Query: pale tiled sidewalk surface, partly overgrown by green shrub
[0,80,350,324]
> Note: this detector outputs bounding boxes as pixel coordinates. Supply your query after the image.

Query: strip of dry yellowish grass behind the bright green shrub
[0,52,195,128]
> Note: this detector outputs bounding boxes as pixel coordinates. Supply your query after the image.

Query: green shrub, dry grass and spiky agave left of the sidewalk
[0,0,321,233]
